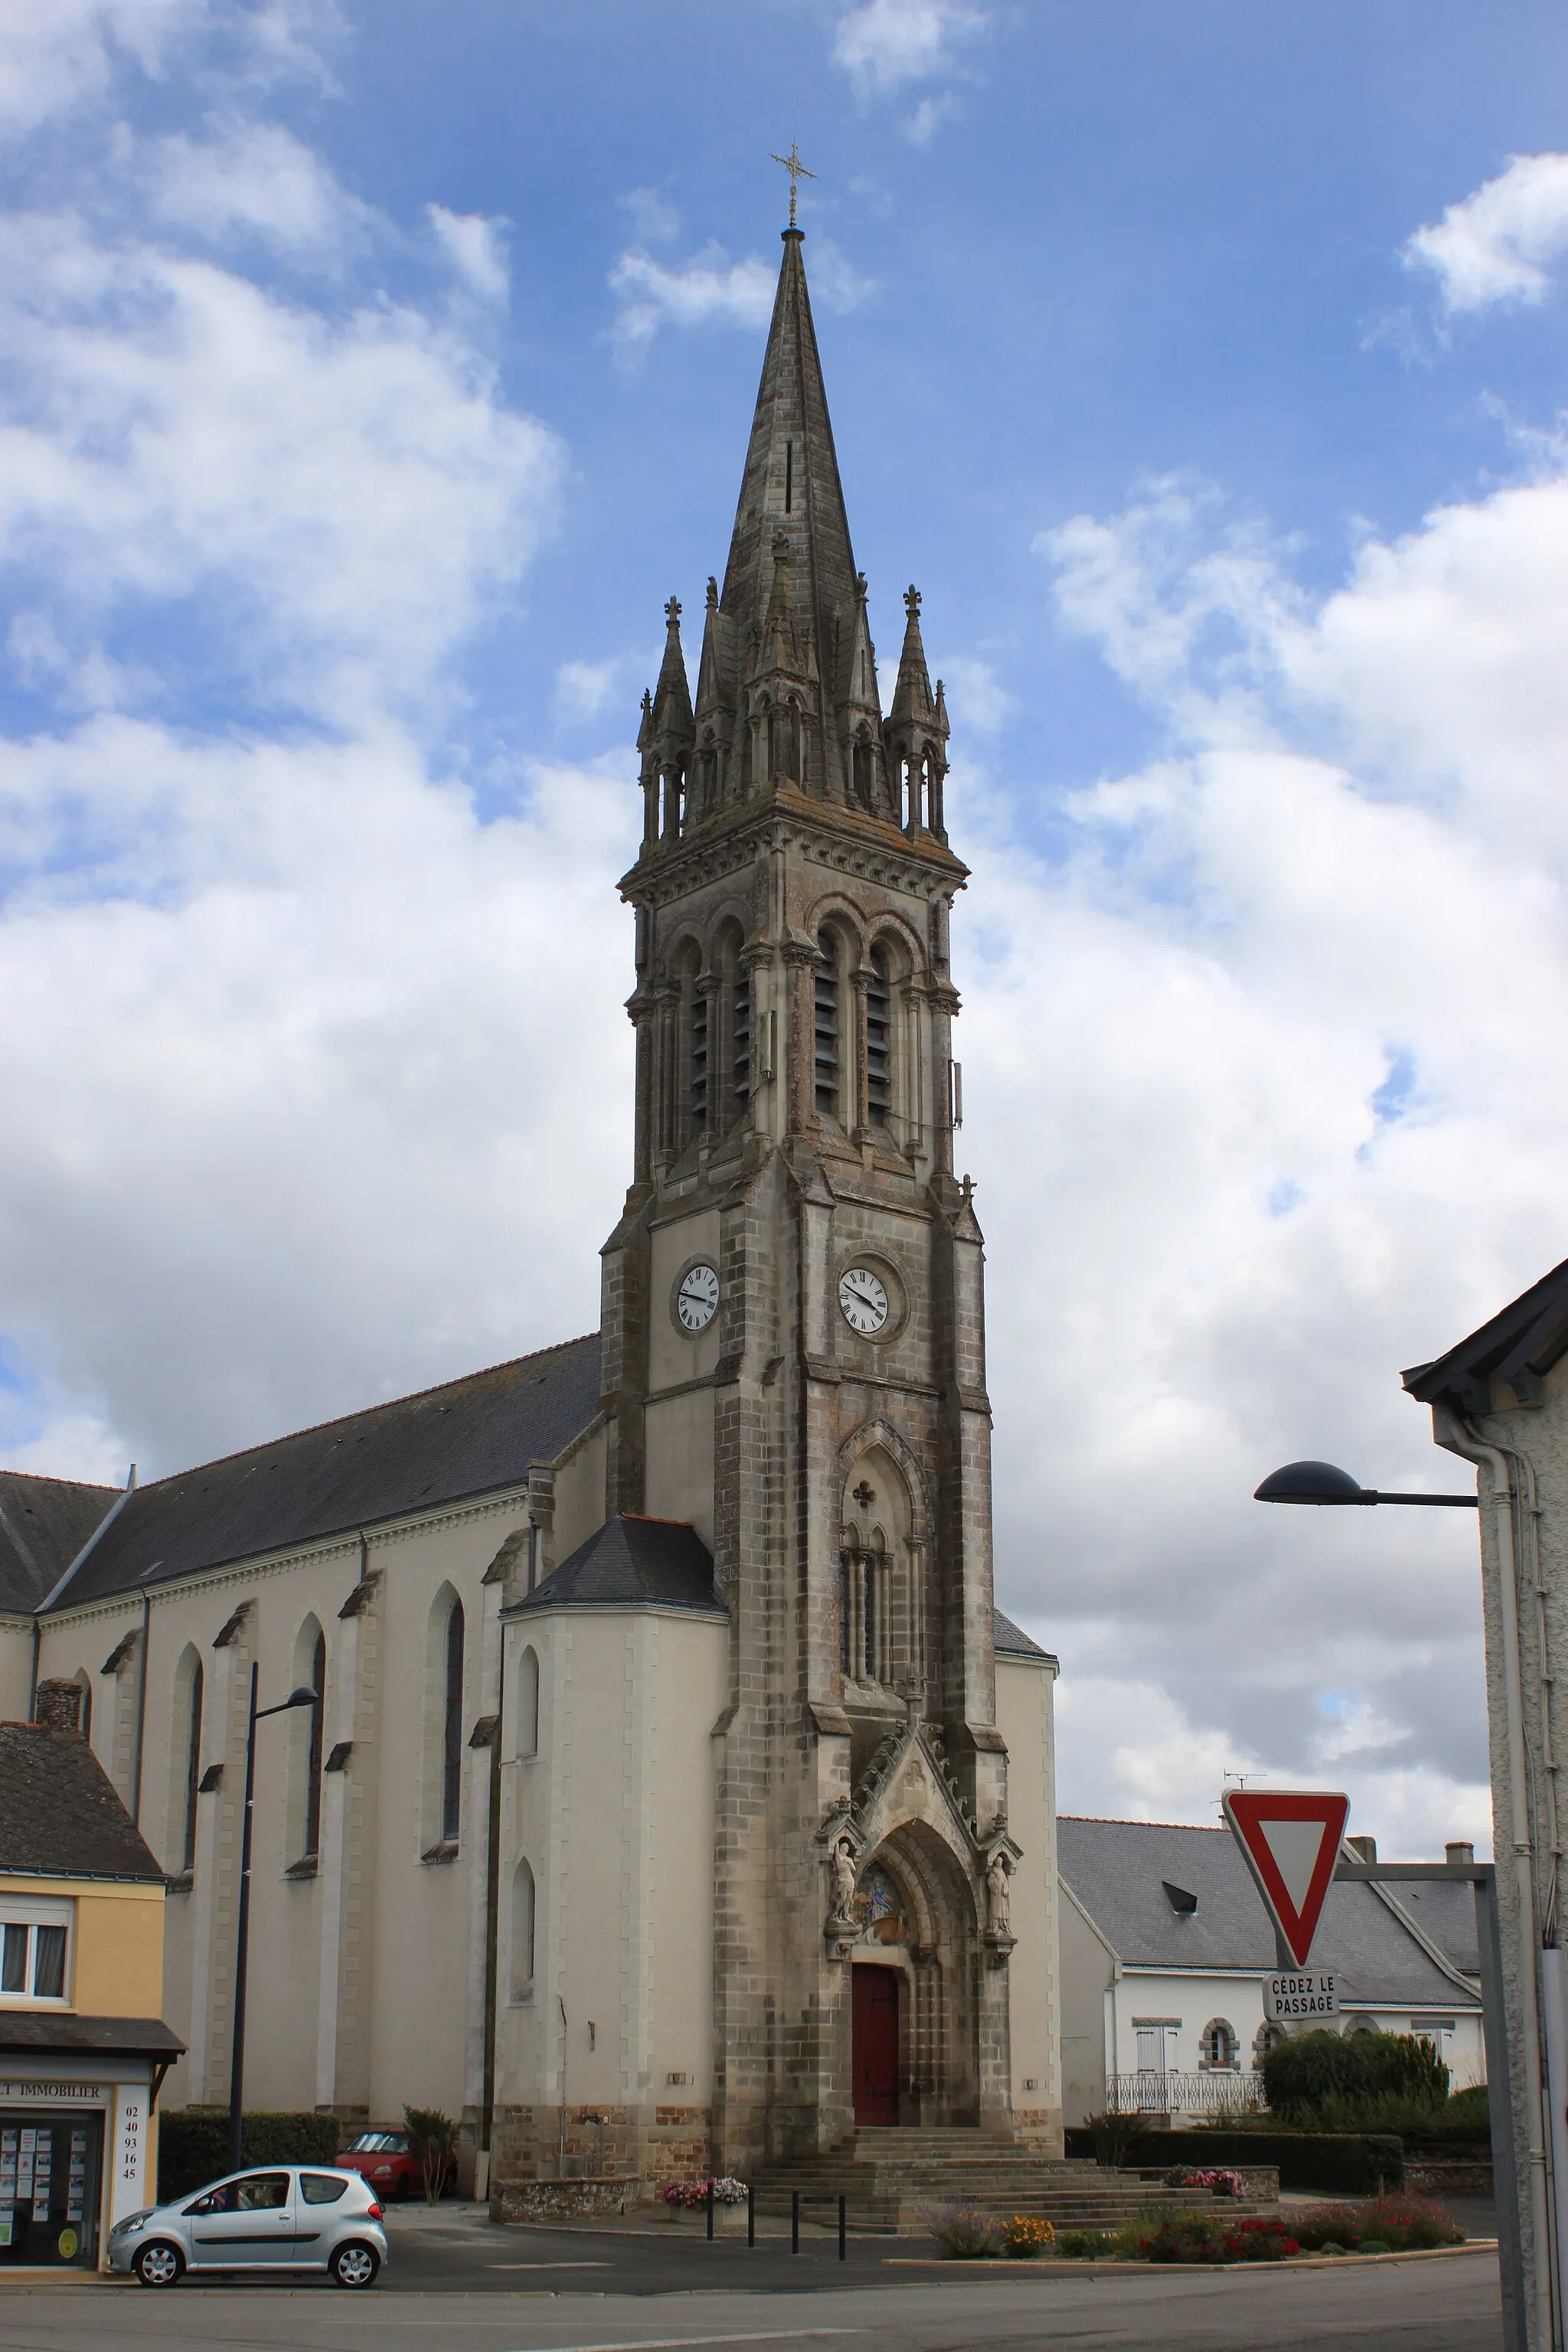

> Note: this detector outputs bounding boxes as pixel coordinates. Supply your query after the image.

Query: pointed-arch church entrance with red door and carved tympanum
[848,1821,980,2126]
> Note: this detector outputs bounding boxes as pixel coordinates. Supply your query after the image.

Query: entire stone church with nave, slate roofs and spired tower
[0,226,1063,2194]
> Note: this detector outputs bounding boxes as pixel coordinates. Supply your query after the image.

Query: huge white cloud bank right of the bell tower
[969,449,1568,1851]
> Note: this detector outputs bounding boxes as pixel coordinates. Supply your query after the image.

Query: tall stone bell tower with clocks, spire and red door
[602,228,1021,2168]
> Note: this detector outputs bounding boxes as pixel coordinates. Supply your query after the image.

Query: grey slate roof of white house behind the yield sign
[1056,1814,1481,2008]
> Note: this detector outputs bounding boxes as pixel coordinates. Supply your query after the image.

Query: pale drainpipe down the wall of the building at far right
[1434,1409,1559,2352]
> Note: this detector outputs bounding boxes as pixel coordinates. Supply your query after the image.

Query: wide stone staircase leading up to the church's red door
[753,2126,1253,2232]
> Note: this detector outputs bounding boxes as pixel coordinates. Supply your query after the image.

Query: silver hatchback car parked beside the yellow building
[108,2164,388,2286]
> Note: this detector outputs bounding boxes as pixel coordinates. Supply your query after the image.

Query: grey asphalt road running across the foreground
[0,2213,1502,2352]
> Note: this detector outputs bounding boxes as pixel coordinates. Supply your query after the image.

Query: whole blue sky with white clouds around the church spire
[0,0,1568,1849]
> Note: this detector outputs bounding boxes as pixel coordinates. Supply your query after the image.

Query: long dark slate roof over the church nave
[57,1331,599,1609]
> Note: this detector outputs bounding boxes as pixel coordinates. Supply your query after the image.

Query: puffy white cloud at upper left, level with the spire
[0,217,560,717]
